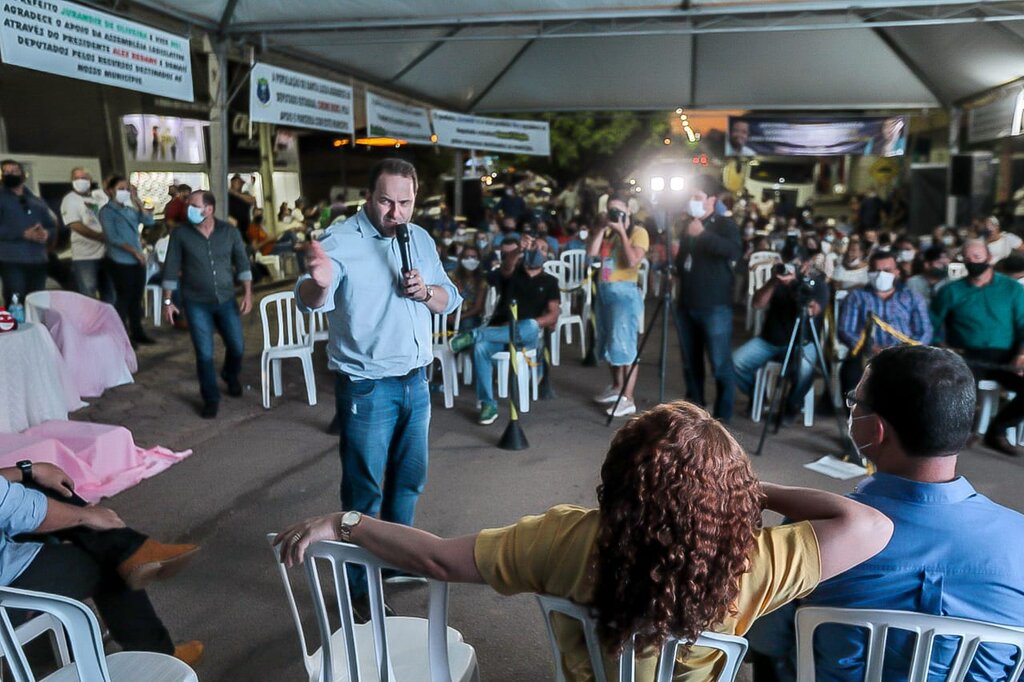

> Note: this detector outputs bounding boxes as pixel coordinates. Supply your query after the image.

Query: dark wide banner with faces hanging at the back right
[725,116,907,157]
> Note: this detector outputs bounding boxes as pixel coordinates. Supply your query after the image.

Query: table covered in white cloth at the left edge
[0,323,84,431]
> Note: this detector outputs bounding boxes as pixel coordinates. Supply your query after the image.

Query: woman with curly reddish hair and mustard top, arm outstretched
[276,401,892,680]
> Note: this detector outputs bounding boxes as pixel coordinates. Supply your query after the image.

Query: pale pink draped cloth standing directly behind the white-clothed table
[26,291,138,396]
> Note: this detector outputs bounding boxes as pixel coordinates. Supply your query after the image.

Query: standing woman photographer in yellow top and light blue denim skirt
[587,197,650,417]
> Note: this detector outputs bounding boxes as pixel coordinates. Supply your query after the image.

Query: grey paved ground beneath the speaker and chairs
[79,288,1021,682]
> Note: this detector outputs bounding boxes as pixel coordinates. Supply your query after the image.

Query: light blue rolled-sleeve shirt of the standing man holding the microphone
[295,211,462,380]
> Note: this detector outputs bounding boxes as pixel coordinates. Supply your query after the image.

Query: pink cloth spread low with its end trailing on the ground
[0,421,191,502]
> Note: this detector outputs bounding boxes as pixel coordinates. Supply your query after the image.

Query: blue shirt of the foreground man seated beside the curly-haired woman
[749,473,1024,682]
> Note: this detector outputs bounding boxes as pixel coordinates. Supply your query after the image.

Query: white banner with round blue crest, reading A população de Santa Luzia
[249,63,355,134]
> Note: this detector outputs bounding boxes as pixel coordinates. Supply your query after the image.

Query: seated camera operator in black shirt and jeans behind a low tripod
[732,237,830,424]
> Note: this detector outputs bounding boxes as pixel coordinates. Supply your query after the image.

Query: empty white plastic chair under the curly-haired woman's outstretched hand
[267,532,479,682]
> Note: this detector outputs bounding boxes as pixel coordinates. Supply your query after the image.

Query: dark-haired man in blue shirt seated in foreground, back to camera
[748,346,1024,682]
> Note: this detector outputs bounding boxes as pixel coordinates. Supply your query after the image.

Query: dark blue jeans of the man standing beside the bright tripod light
[676,305,736,421]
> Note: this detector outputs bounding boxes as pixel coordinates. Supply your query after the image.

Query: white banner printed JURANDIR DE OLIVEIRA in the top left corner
[0,0,195,101]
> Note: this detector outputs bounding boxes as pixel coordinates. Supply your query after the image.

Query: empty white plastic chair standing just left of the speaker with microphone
[259,291,316,410]
